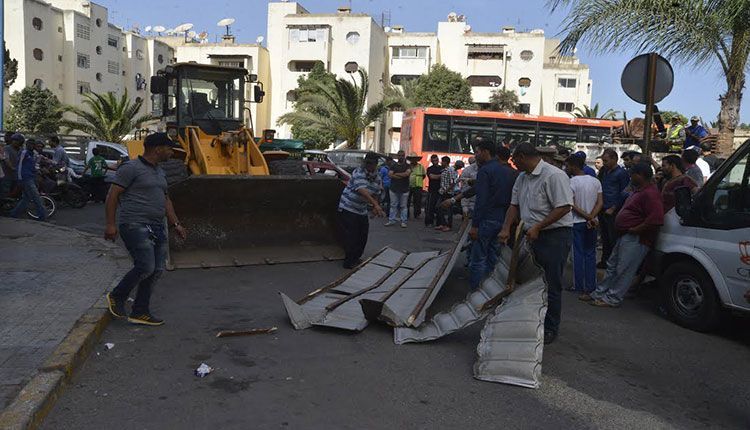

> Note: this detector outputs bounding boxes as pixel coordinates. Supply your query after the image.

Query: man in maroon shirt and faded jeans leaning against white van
[589,162,664,307]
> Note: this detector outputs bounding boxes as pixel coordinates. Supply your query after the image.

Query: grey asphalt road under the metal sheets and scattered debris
[43,205,750,429]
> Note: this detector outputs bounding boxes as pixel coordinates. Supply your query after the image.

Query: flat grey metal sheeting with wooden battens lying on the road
[279,223,469,331]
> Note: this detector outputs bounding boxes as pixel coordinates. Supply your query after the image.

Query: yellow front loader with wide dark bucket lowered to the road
[127,63,343,268]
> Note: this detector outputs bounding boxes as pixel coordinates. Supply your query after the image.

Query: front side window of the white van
[704,149,750,229]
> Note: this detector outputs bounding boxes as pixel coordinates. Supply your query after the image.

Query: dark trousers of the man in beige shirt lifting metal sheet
[531,227,573,333]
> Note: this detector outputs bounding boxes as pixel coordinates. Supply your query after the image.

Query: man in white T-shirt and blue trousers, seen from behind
[565,156,604,294]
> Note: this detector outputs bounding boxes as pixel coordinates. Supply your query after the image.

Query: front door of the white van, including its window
[696,144,750,310]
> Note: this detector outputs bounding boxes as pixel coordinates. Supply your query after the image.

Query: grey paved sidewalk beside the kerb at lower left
[0,218,130,410]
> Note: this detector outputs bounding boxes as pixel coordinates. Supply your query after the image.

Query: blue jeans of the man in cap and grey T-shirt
[112,223,168,315]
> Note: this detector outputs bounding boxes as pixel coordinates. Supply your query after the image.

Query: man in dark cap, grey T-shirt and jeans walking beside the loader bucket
[104,133,186,326]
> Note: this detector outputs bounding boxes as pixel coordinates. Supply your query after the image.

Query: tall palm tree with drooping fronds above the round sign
[548,0,750,154]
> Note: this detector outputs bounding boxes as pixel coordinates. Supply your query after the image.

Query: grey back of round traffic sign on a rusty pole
[620,54,674,104]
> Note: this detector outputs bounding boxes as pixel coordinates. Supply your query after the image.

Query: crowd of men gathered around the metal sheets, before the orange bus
[339,129,719,343]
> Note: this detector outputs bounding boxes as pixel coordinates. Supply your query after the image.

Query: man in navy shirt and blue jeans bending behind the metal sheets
[469,144,516,290]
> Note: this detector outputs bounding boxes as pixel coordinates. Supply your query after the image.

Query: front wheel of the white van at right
[661,261,723,332]
